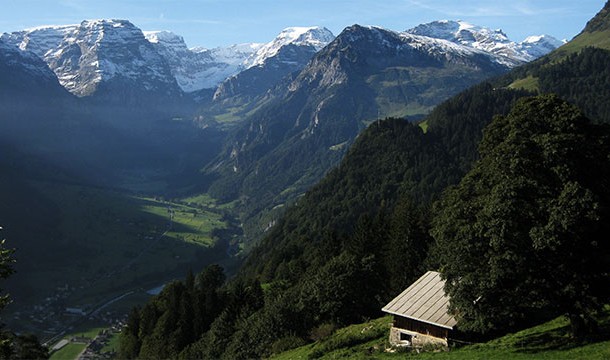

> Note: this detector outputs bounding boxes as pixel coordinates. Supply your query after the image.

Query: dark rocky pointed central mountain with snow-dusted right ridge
[201,25,560,239]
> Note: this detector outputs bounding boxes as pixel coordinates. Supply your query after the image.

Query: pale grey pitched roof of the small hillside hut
[382,271,457,329]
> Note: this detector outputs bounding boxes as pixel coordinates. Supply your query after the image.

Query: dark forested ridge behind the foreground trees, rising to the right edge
[244,43,610,279]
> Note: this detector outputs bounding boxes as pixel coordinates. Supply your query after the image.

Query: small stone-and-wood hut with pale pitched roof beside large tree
[382,271,457,347]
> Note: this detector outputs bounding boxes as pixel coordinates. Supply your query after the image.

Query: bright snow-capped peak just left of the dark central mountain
[244,26,335,68]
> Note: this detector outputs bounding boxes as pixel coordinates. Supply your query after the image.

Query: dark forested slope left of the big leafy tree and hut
[117,84,526,358]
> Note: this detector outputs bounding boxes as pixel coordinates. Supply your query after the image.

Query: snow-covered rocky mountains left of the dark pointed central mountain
[2,20,333,97]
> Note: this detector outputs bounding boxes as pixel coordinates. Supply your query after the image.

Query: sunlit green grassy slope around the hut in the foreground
[273,307,610,360]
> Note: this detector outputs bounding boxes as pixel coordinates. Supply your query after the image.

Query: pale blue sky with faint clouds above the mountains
[0,0,606,47]
